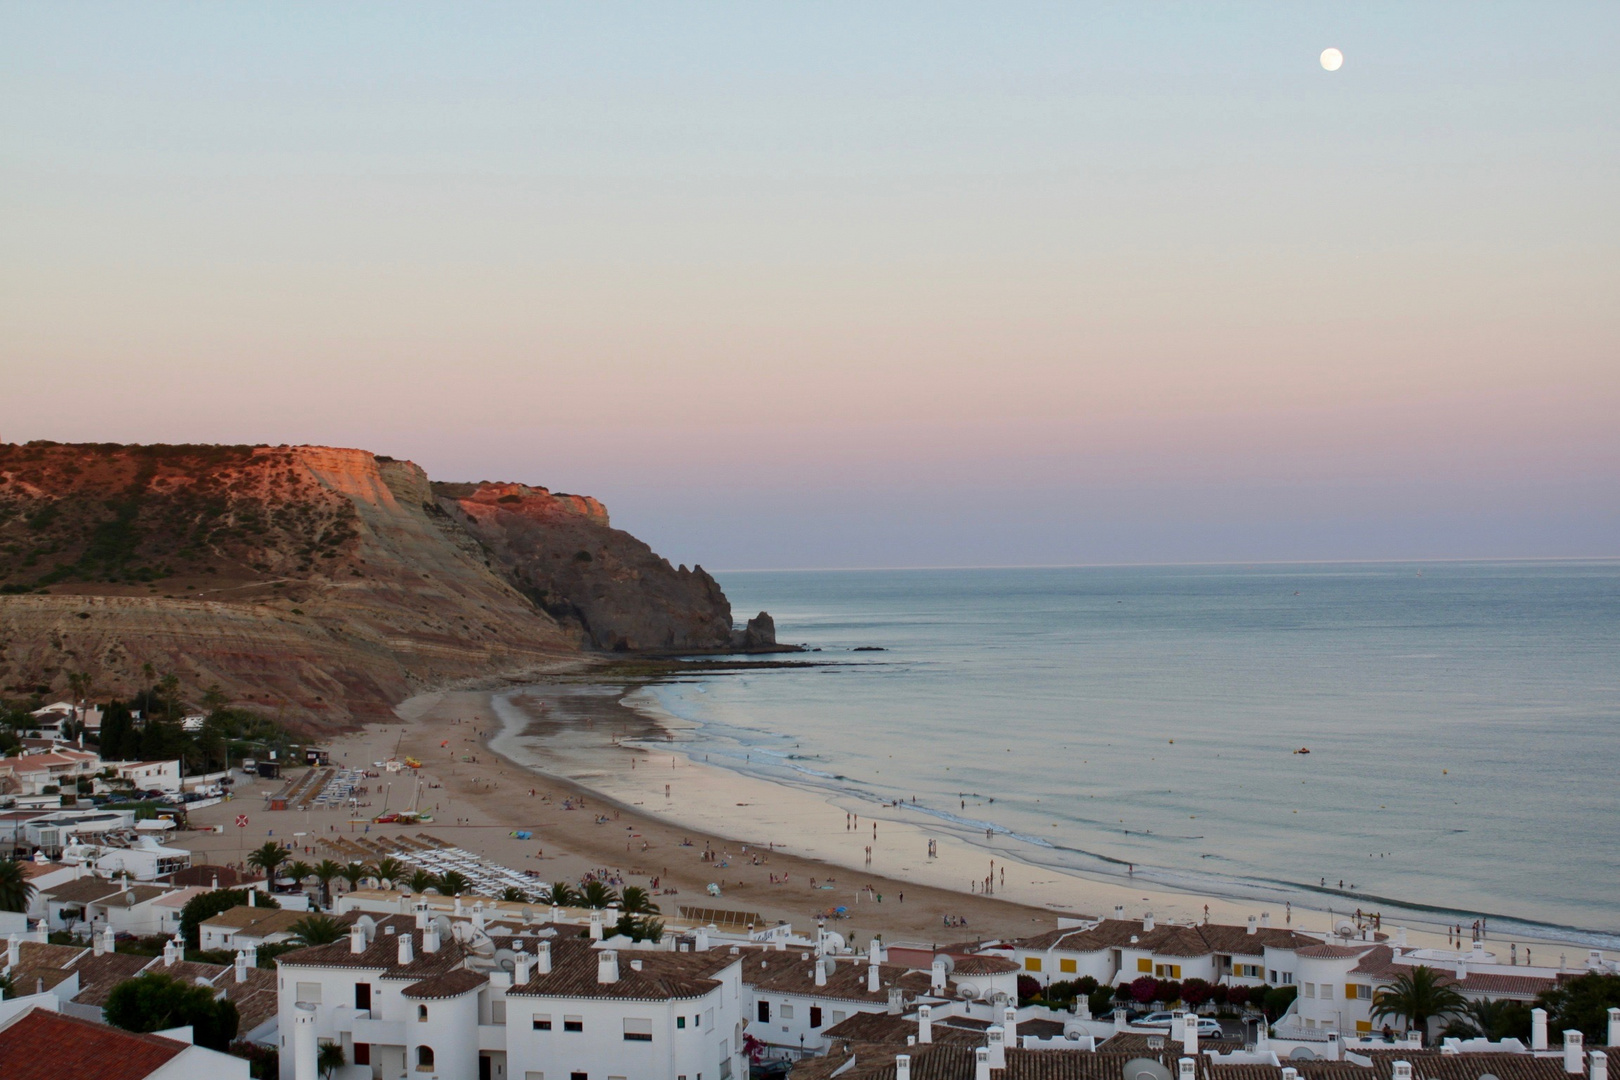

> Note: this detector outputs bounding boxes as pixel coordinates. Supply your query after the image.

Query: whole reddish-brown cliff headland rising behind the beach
[0,444,774,724]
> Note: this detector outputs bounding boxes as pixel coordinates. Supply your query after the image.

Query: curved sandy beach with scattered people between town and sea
[177,674,1529,949]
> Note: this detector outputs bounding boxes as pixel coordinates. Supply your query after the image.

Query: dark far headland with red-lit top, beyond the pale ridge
[434,484,735,653]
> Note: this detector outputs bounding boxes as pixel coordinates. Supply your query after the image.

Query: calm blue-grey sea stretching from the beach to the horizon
[645,560,1620,947]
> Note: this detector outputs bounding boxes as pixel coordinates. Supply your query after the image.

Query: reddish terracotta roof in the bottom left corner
[0,1009,186,1080]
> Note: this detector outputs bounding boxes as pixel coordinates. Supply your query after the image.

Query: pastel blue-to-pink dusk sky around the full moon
[0,0,1620,568]
